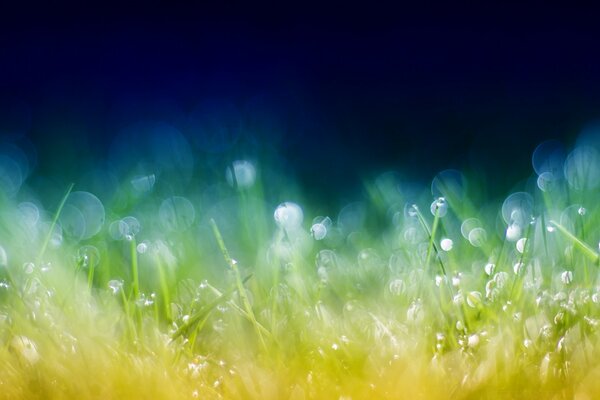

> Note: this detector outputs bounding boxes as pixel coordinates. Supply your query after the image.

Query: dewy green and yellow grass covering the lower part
[0,138,600,400]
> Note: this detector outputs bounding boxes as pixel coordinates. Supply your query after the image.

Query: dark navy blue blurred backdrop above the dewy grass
[0,1,600,206]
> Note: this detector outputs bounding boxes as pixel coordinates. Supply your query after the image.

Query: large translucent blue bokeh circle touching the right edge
[564,146,600,190]
